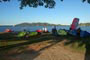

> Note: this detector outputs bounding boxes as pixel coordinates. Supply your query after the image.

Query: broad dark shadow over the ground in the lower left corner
[0,47,40,60]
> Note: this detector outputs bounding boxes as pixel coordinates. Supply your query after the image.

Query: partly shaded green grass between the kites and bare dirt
[0,32,90,51]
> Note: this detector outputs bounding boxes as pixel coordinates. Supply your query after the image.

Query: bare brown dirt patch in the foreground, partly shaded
[2,40,85,60]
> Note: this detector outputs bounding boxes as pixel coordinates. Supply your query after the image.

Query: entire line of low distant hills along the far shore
[0,22,90,27]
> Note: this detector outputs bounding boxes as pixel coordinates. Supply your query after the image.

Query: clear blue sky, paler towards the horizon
[0,0,90,25]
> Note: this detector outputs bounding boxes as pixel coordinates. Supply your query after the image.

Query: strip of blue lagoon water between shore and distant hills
[0,26,90,32]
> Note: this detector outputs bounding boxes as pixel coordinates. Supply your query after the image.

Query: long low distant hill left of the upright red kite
[15,22,60,26]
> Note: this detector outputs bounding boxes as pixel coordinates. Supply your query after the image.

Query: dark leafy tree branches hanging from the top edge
[0,0,90,9]
